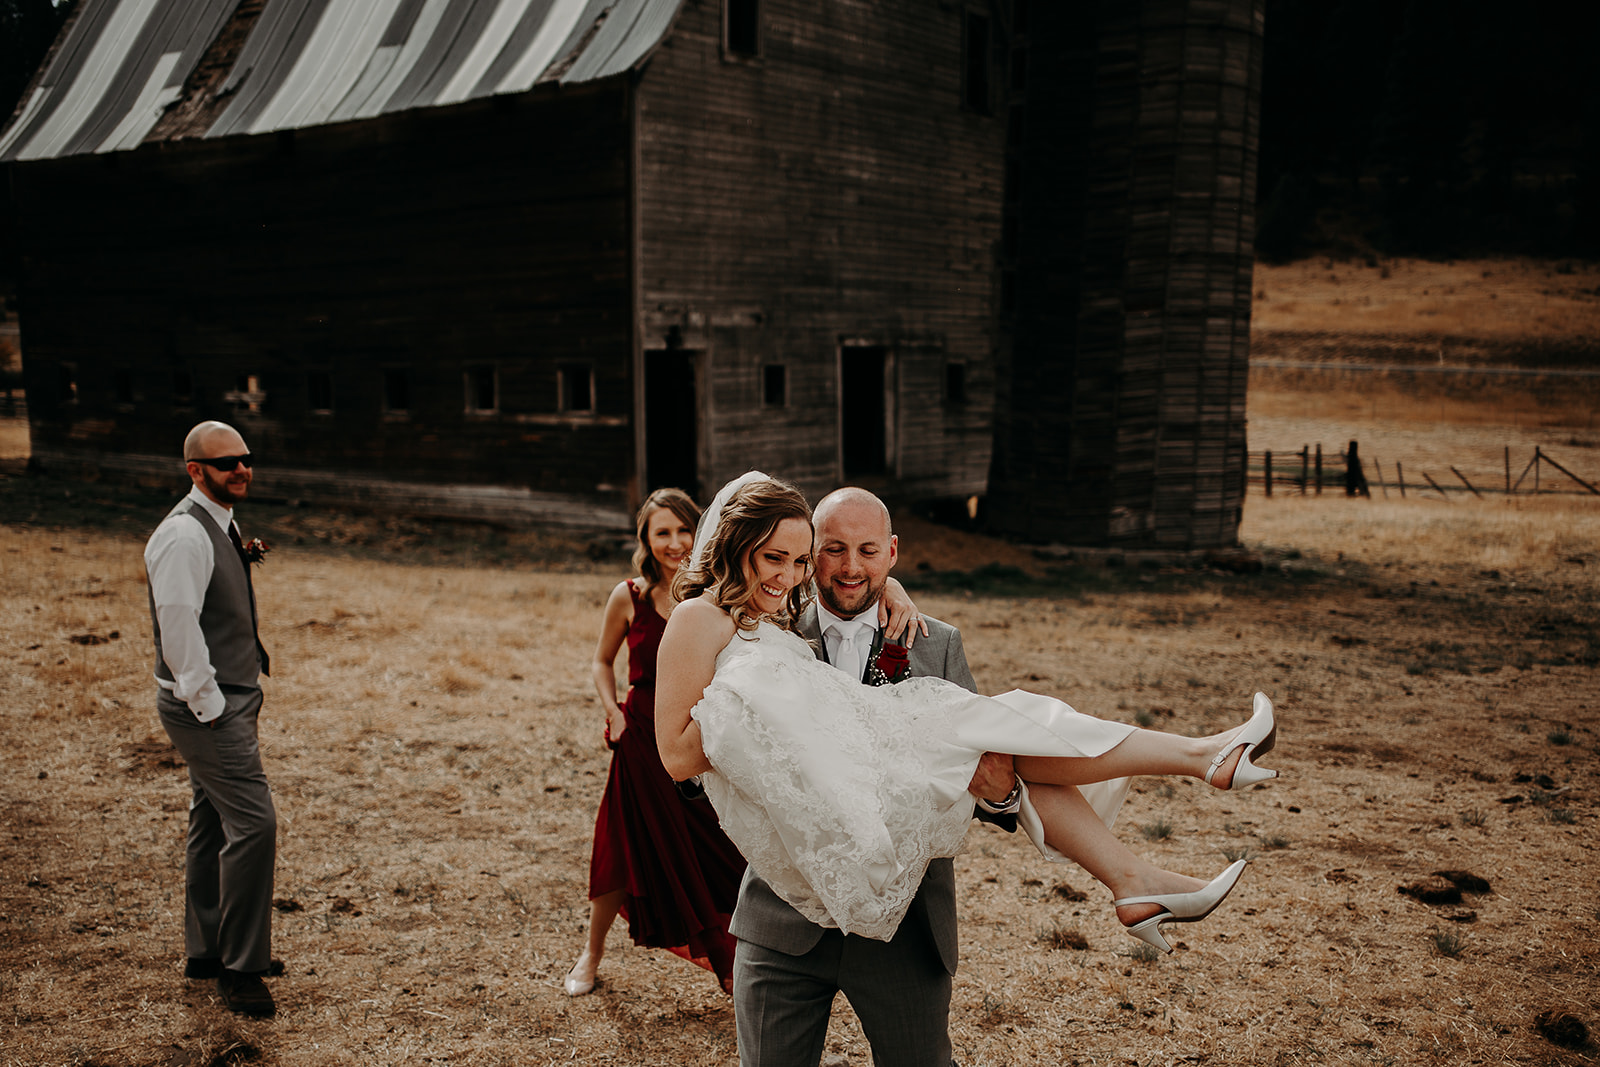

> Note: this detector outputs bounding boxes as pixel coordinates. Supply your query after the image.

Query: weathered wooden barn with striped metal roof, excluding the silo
[0,0,1005,525]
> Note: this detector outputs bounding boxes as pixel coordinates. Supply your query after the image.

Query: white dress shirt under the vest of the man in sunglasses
[144,486,234,723]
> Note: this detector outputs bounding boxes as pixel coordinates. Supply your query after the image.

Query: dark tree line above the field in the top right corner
[1258,0,1600,259]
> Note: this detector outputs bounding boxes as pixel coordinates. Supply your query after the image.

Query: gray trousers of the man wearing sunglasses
[155,686,278,973]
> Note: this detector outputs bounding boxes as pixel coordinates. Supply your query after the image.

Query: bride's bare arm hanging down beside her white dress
[656,598,734,782]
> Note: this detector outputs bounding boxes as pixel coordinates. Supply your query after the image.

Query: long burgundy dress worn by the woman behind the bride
[589,582,744,992]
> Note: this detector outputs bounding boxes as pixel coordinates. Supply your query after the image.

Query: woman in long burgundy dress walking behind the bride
[563,490,744,997]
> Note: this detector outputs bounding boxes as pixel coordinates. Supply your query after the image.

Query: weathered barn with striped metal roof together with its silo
[0,0,1264,552]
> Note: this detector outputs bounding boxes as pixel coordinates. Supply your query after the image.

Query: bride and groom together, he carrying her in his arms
[656,470,1277,1067]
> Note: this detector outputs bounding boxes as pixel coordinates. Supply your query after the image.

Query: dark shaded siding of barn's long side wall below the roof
[10,83,634,512]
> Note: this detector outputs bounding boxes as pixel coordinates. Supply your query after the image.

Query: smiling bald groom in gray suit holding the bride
[728,488,1021,1067]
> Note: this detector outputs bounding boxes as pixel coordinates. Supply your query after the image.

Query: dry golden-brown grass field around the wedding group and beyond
[0,264,1600,1067]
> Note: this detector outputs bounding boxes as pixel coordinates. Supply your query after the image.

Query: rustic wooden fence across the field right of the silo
[1245,442,1600,501]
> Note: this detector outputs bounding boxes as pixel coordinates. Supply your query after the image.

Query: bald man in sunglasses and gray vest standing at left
[144,422,283,1016]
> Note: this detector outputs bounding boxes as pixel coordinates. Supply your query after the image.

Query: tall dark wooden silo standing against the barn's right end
[989,0,1264,552]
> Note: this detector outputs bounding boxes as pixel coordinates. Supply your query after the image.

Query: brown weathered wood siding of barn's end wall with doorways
[638,0,1003,498]
